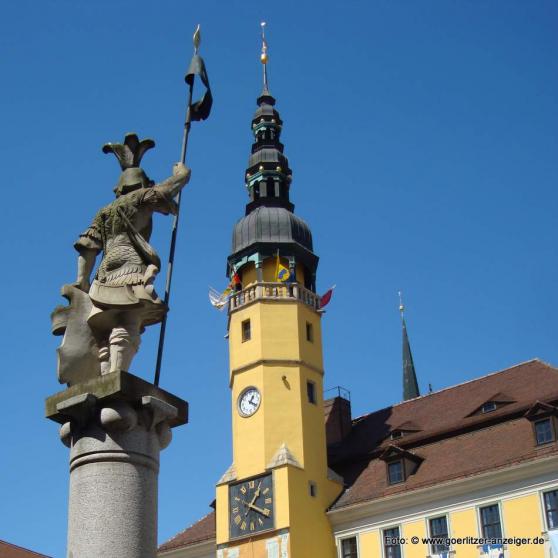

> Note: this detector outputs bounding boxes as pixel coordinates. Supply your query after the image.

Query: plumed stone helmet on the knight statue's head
[103,133,155,197]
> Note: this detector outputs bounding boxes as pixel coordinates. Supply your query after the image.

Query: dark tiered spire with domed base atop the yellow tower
[227,21,318,291]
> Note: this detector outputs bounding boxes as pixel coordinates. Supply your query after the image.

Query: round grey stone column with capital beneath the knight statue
[46,372,188,558]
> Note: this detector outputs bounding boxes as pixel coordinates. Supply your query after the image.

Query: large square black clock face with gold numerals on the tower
[229,475,275,539]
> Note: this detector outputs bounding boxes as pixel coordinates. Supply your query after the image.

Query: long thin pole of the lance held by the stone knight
[153,25,201,386]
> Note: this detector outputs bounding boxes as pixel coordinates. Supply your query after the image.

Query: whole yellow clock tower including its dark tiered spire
[216,24,342,558]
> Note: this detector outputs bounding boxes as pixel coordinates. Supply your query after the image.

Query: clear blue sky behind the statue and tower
[0,0,558,557]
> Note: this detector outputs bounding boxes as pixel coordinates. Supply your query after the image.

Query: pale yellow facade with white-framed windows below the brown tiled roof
[329,457,558,558]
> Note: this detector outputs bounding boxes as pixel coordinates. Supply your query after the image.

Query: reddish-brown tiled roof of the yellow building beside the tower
[330,360,558,509]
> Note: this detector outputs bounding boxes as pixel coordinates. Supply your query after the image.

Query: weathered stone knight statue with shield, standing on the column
[52,134,190,384]
